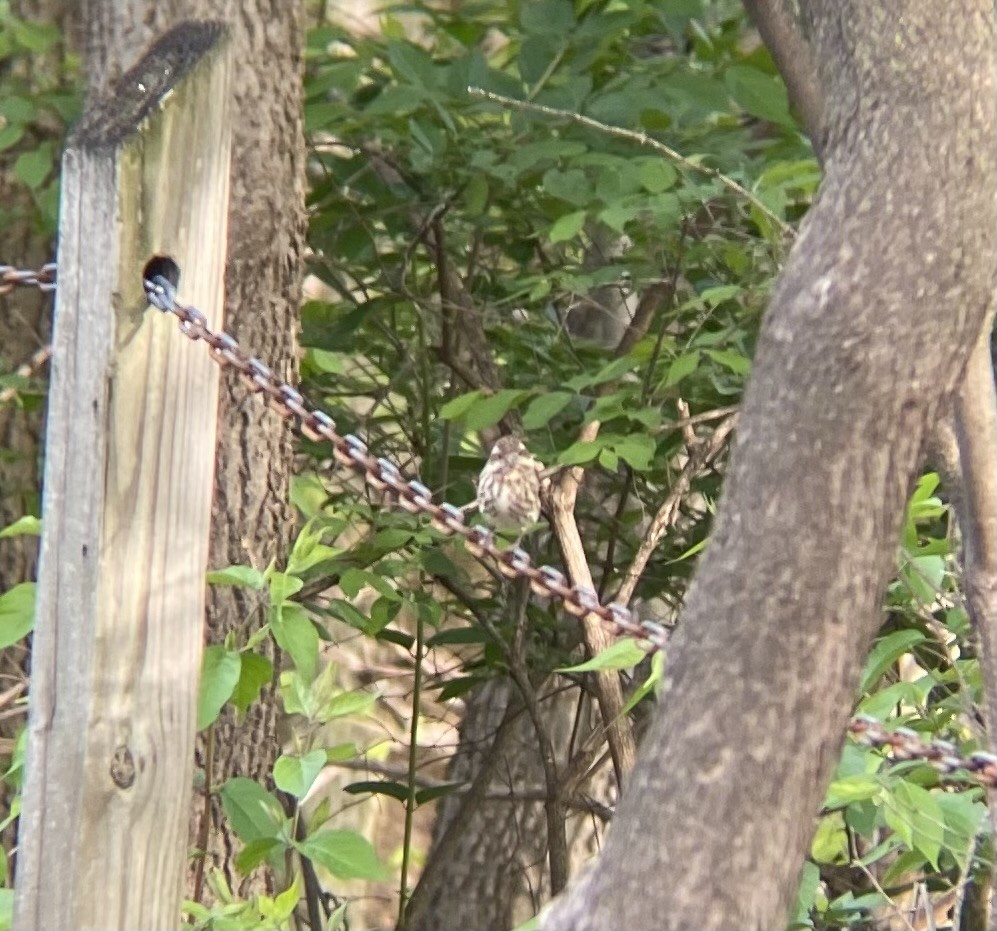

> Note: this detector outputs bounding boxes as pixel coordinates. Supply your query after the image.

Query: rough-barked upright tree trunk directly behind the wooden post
[84,0,304,904]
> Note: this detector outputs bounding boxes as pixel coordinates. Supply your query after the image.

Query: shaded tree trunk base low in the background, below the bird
[404,676,616,931]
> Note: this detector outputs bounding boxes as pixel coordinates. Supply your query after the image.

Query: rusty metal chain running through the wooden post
[7,262,997,787]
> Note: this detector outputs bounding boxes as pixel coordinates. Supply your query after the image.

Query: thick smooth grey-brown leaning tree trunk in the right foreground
[544,0,997,929]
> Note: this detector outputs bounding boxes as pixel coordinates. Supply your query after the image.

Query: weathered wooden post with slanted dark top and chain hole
[15,23,231,928]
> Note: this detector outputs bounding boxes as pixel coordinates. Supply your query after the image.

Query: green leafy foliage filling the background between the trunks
[0,0,993,928]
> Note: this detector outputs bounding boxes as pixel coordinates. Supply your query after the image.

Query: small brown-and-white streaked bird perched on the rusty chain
[478,436,543,534]
